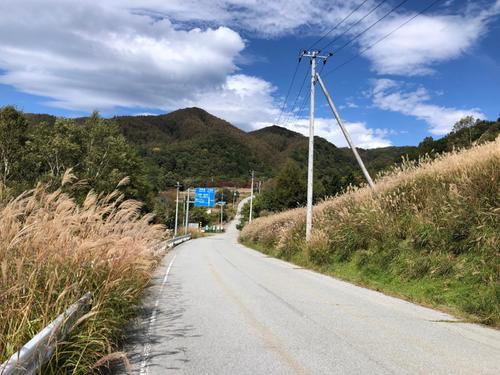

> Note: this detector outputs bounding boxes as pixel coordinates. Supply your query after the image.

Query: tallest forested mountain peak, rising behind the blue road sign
[112,108,273,184]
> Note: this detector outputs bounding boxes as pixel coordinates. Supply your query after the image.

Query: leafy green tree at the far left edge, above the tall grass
[0,106,28,186]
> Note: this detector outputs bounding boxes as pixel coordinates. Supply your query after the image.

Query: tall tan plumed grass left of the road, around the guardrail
[0,172,165,374]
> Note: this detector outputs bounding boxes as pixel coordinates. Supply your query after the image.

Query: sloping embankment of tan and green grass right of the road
[240,138,500,327]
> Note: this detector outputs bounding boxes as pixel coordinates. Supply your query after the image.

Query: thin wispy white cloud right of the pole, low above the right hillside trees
[372,79,485,135]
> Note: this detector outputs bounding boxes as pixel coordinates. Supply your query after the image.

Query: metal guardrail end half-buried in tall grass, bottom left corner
[0,292,92,375]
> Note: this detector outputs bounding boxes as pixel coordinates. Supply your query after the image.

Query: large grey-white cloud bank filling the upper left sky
[0,0,245,110]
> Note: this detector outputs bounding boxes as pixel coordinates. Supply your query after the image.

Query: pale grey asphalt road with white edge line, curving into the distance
[120,206,500,375]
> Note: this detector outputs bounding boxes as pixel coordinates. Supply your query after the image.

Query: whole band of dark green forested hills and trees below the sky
[21,107,500,228]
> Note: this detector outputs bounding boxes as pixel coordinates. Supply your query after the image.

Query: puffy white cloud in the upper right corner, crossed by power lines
[360,0,500,76]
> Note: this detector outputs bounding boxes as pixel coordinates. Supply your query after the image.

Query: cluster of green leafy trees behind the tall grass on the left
[0,106,151,208]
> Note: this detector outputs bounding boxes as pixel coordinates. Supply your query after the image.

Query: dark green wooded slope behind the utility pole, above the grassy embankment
[252,116,500,217]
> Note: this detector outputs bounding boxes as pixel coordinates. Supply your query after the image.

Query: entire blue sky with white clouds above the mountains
[0,0,500,148]
